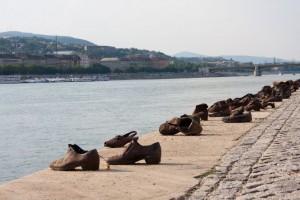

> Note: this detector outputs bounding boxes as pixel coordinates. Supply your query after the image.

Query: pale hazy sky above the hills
[0,0,300,60]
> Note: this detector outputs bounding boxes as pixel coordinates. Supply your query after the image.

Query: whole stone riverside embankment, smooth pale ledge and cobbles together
[0,85,300,200]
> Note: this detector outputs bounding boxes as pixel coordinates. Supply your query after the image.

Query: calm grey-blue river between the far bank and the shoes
[0,75,300,184]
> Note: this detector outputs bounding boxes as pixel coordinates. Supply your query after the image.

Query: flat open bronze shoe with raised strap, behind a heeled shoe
[104,131,139,148]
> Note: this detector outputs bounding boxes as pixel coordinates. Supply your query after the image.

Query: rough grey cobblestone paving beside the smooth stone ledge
[189,91,300,200]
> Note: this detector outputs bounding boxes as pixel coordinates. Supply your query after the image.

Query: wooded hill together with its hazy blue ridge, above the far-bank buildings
[0,31,170,59]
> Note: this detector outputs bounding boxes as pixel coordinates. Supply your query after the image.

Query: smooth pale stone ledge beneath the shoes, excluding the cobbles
[0,99,281,199]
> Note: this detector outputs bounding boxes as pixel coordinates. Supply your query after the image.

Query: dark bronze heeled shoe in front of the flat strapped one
[107,140,161,165]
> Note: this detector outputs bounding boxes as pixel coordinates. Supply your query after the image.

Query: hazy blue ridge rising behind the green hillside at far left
[0,31,95,46]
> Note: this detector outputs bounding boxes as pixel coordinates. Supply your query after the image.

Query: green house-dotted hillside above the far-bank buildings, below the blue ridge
[0,33,170,59]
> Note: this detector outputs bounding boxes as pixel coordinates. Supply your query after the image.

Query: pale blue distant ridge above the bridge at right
[221,55,288,64]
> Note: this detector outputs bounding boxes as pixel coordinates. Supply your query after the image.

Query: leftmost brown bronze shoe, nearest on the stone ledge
[50,144,100,171]
